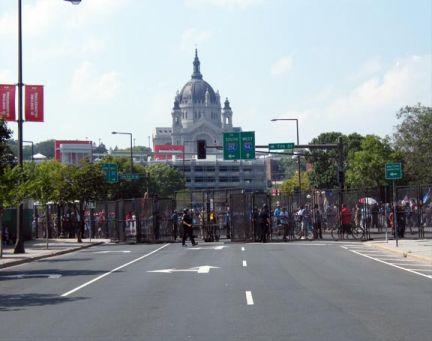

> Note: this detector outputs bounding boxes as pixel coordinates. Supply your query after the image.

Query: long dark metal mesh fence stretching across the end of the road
[28,185,432,242]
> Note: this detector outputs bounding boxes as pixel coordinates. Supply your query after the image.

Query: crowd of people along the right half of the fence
[252,199,432,242]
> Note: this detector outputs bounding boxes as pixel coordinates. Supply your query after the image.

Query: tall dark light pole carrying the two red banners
[14,0,81,253]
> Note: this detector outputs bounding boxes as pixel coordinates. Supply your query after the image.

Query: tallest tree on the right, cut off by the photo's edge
[393,103,432,184]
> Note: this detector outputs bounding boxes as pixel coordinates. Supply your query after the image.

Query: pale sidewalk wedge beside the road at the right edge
[367,239,432,264]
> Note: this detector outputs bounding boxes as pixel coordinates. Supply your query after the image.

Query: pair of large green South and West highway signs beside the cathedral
[224,131,255,160]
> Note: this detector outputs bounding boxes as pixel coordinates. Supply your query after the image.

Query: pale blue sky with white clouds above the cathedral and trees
[0,0,432,147]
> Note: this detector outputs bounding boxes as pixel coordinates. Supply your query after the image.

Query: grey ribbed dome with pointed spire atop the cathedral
[177,50,218,104]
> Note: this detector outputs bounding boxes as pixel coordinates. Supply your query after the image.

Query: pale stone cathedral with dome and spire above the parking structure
[153,50,241,159]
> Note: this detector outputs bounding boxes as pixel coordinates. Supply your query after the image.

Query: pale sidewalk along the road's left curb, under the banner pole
[0,238,110,269]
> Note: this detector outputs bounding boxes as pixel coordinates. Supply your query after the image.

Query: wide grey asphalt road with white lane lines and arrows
[0,242,432,341]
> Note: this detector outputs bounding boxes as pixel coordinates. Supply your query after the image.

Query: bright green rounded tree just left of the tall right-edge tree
[346,135,400,188]
